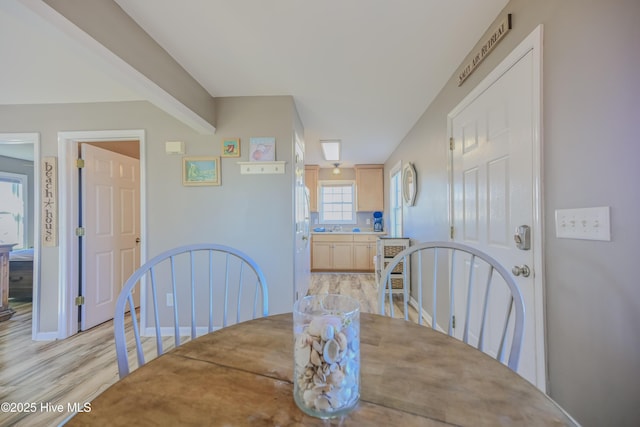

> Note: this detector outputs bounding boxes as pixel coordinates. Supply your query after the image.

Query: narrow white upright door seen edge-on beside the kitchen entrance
[293,134,311,301]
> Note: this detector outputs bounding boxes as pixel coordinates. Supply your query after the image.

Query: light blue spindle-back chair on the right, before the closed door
[378,242,525,371]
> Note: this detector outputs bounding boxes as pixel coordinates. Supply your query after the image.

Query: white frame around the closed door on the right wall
[447,25,549,391]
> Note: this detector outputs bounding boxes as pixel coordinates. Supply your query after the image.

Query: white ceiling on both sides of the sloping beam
[0,0,508,166]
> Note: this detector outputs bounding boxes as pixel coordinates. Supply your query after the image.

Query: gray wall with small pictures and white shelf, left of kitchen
[0,97,297,332]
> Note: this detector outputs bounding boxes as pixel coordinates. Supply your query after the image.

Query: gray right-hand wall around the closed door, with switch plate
[385,0,640,426]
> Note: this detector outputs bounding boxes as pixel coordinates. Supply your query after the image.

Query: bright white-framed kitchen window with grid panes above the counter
[319,181,356,224]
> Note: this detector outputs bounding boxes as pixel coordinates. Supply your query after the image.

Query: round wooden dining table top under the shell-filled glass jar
[67,313,575,426]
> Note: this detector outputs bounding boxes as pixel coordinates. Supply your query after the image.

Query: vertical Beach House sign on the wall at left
[40,157,58,246]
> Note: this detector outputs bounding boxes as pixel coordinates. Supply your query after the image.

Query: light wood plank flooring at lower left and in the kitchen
[0,273,415,427]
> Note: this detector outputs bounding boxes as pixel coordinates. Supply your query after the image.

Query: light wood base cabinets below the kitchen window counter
[311,233,378,272]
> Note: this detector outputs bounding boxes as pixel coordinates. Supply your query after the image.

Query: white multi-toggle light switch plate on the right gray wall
[556,206,611,241]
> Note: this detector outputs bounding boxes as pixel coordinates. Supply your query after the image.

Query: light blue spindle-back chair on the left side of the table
[113,243,268,378]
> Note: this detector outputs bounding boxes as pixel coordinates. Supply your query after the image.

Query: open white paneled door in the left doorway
[80,144,140,330]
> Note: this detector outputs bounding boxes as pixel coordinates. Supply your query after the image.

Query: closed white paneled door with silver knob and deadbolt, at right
[449,37,546,390]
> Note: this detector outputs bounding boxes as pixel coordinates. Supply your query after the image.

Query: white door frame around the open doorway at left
[58,129,147,339]
